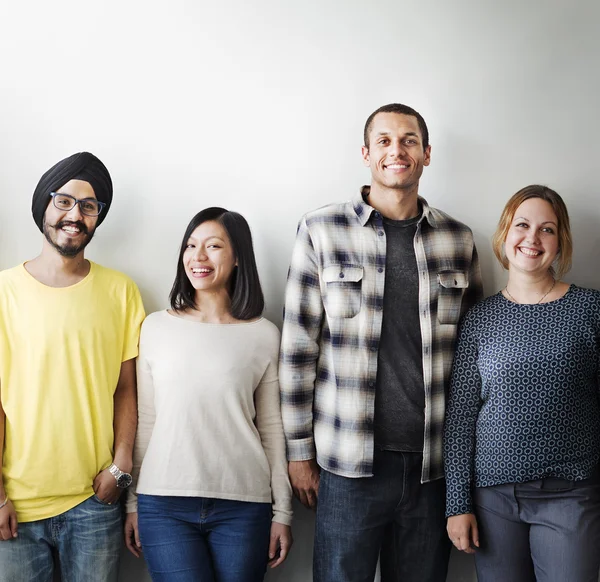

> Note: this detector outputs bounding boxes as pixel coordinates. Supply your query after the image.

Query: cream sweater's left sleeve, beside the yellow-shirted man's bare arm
[125,327,156,513]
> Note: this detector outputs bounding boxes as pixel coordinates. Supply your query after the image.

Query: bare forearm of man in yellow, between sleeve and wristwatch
[114,360,137,472]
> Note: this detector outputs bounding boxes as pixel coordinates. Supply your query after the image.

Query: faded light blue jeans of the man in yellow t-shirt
[0,496,123,582]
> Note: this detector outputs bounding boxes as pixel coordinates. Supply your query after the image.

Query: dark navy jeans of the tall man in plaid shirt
[313,451,450,582]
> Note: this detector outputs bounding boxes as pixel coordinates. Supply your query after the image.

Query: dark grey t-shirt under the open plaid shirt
[375,216,425,453]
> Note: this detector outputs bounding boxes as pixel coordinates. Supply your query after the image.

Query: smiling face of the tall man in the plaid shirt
[362,113,431,194]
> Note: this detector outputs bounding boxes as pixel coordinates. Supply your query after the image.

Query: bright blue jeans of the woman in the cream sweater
[138,495,272,582]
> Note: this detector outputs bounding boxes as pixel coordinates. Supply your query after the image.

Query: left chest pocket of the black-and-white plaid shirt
[322,265,363,317]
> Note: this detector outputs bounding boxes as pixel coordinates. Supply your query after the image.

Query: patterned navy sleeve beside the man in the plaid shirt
[444,313,482,517]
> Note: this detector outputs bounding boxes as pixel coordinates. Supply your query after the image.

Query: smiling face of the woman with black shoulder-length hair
[183,220,237,292]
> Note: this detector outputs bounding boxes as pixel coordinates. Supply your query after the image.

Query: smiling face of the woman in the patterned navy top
[504,198,559,274]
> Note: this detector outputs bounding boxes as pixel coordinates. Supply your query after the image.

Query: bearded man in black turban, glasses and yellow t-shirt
[0,152,144,582]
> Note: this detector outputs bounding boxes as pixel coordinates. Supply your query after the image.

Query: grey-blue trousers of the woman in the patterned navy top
[474,477,600,582]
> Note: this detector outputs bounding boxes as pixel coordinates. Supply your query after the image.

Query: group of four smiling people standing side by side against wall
[0,104,600,582]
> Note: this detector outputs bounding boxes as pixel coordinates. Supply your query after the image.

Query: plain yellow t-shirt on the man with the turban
[0,263,144,522]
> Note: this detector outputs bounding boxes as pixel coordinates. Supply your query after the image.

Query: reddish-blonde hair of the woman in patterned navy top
[492,184,573,279]
